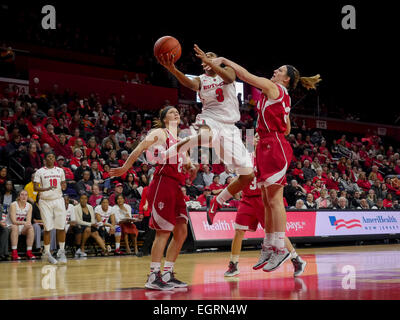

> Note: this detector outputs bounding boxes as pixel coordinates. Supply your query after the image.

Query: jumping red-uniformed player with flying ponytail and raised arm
[206,57,321,272]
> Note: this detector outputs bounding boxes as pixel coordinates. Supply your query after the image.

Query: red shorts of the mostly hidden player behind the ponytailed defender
[235,195,265,231]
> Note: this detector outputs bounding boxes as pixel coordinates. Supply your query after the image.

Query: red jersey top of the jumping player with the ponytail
[257,83,291,138]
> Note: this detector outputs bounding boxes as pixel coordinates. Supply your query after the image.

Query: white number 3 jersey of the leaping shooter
[199,74,240,124]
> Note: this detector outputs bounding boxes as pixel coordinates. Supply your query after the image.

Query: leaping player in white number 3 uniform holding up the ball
[160,45,254,224]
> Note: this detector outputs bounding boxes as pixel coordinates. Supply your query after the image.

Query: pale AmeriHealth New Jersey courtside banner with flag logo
[315,210,400,236]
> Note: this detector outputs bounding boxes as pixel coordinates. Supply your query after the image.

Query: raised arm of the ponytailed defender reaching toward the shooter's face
[211,57,279,100]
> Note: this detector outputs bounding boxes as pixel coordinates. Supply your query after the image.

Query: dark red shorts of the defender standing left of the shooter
[147,176,188,231]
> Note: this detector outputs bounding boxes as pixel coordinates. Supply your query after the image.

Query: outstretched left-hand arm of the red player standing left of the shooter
[110,129,166,177]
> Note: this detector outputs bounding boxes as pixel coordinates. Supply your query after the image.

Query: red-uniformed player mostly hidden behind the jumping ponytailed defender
[224,134,306,277]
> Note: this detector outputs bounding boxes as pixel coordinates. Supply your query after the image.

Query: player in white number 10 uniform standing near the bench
[33,152,67,264]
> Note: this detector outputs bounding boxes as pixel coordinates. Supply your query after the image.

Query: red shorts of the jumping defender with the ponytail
[256,132,293,187]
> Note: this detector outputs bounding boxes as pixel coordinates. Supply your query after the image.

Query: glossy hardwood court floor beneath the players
[0,244,400,300]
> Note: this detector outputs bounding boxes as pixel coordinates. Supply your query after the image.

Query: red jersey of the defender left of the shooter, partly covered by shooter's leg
[154,129,186,185]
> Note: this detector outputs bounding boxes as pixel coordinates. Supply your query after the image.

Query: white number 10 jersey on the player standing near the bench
[33,167,65,200]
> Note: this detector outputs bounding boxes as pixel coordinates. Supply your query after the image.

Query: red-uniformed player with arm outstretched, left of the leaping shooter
[110,106,196,290]
